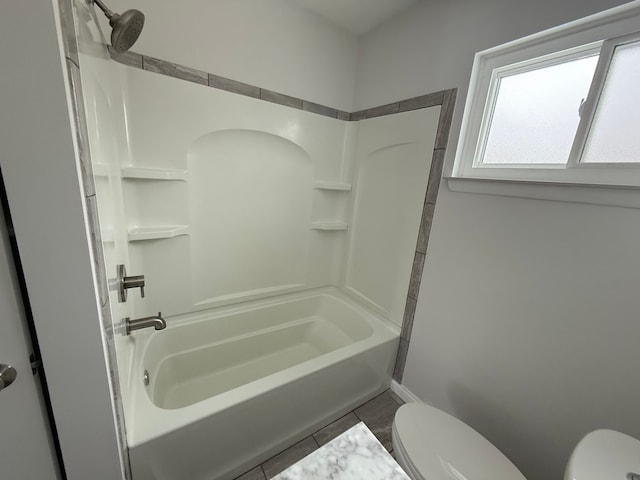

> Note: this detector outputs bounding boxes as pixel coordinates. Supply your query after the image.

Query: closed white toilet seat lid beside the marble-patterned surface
[392,403,526,480]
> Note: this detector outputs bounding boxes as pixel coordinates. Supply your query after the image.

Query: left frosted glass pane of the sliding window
[482,55,598,165]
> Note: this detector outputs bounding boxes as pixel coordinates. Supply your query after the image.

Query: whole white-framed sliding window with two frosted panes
[454,2,640,186]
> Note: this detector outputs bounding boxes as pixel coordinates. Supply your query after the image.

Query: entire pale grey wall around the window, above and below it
[356,0,640,480]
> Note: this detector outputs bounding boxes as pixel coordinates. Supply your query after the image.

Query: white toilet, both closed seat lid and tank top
[392,403,640,480]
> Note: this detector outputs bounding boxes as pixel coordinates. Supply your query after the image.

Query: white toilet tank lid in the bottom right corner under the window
[565,430,640,480]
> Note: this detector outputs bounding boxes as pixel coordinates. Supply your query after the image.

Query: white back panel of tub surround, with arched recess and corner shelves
[119,69,356,317]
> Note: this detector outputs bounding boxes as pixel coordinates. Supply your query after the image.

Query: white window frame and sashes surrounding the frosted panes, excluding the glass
[451,1,640,187]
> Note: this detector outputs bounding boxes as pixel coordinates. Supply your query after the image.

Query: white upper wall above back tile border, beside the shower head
[100,0,357,111]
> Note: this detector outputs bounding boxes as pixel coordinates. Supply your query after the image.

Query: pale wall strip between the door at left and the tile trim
[0,0,123,480]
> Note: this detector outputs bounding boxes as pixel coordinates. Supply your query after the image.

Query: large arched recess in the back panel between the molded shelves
[187,129,314,305]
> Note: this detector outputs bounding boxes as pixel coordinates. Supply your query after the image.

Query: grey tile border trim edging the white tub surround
[59,0,456,479]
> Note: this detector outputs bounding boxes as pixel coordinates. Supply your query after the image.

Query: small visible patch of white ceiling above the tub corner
[291,0,420,35]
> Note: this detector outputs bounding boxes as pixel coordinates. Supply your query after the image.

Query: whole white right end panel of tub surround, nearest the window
[344,107,440,326]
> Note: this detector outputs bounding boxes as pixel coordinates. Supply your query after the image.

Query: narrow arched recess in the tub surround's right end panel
[347,143,429,318]
